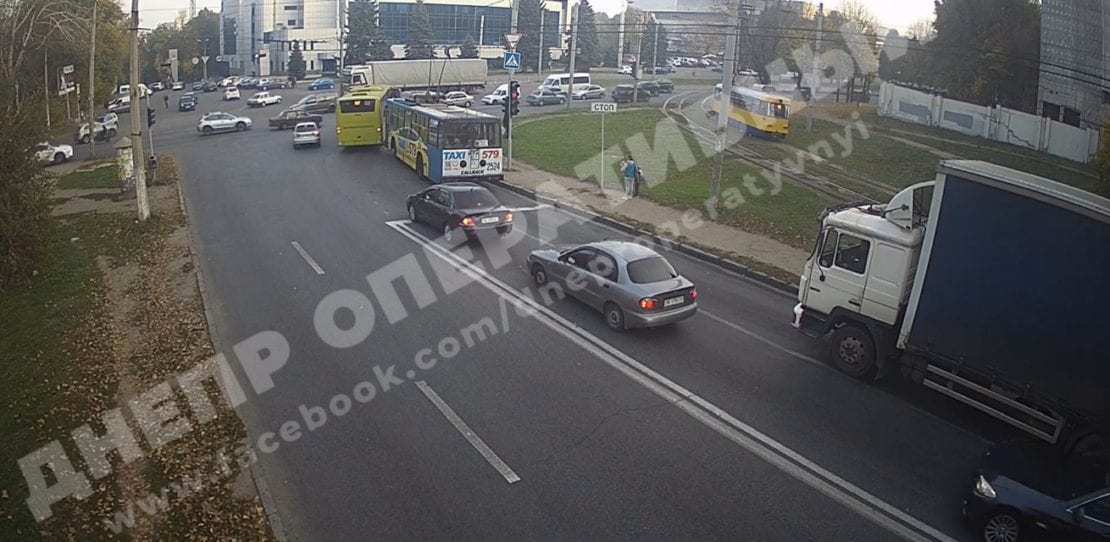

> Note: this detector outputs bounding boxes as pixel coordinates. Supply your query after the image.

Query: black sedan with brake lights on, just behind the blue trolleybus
[406,182,513,243]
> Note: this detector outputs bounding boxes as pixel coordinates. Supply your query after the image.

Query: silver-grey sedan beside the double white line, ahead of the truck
[528,241,697,331]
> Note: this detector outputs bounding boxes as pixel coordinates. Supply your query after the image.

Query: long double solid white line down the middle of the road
[386,221,955,542]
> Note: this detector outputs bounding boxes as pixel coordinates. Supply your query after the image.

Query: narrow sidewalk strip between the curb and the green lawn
[505,161,809,279]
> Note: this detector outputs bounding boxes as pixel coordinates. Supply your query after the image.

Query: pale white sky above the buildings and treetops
[132,0,932,35]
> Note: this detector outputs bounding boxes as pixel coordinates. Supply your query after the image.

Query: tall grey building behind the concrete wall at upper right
[1037,0,1110,128]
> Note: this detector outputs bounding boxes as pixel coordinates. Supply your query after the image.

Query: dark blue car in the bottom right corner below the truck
[963,442,1110,542]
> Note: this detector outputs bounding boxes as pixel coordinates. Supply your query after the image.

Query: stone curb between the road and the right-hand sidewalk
[494,181,798,295]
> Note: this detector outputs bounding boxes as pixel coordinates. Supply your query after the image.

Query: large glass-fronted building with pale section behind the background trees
[220,0,568,76]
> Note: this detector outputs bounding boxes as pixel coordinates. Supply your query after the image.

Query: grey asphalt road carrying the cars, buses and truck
[155,89,1007,541]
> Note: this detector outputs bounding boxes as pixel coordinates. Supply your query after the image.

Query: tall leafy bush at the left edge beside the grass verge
[0,96,51,291]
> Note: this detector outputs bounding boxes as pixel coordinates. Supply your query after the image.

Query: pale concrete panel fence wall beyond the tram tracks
[879,83,1099,163]
